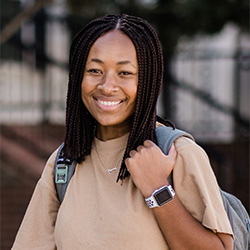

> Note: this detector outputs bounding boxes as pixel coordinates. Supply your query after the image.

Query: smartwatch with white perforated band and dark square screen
[145,185,175,208]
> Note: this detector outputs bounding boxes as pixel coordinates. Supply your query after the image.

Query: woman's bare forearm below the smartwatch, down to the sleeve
[153,191,233,250]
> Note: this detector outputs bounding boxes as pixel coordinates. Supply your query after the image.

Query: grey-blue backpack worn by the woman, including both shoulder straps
[54,126,250,250]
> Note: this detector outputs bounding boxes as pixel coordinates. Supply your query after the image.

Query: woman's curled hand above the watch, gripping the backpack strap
[125,140,177,198]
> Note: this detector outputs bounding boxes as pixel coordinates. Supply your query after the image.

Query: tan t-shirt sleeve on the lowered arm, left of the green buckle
[12,149,59,250]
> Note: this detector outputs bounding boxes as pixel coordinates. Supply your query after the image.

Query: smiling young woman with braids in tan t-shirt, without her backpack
[12,15,233,250]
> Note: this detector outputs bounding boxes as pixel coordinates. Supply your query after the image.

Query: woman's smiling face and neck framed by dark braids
[81,30,138,138]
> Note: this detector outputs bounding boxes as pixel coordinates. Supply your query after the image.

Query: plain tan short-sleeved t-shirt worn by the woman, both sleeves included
[12,135,233,250]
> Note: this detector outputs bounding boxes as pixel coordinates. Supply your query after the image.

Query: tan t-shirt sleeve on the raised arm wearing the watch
[173,137,233,235]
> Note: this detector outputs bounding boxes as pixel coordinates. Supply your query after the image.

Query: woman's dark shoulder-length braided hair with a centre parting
[63,14,173,181]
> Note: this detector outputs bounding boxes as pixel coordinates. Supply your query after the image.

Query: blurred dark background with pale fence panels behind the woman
[0,0,250,250]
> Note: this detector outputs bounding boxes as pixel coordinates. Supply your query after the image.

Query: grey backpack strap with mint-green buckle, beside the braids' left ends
[54,143,76,203]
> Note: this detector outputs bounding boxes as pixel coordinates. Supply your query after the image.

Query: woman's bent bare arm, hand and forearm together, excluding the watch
[125,140,233,250]
